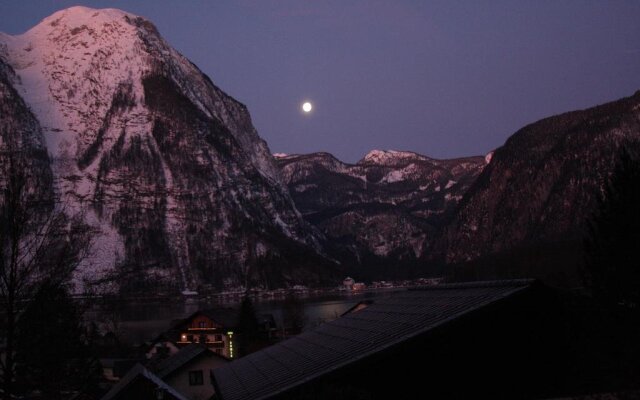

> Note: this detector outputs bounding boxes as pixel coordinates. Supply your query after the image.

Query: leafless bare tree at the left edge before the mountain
[0,147,91,398]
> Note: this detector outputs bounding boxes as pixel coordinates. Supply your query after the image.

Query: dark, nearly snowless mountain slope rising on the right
[444,92,640,262]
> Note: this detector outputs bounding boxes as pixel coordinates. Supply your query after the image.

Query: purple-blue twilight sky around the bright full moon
[0,0,640,162]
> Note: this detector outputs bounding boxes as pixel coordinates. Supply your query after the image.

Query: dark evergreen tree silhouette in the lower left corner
[16,283,102,399]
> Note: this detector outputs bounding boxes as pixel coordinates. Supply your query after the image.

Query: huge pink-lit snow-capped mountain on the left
[0,7,327,289]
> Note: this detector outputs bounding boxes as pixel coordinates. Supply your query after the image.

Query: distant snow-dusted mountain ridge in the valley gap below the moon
[276,150,488,261]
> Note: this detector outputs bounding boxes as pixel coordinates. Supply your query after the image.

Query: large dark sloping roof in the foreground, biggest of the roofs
[213,280,533,400]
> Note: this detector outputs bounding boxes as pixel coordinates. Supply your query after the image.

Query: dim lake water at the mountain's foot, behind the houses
[86,290,404,344]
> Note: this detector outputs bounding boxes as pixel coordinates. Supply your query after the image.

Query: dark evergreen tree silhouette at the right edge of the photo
[585,150,640,308]
